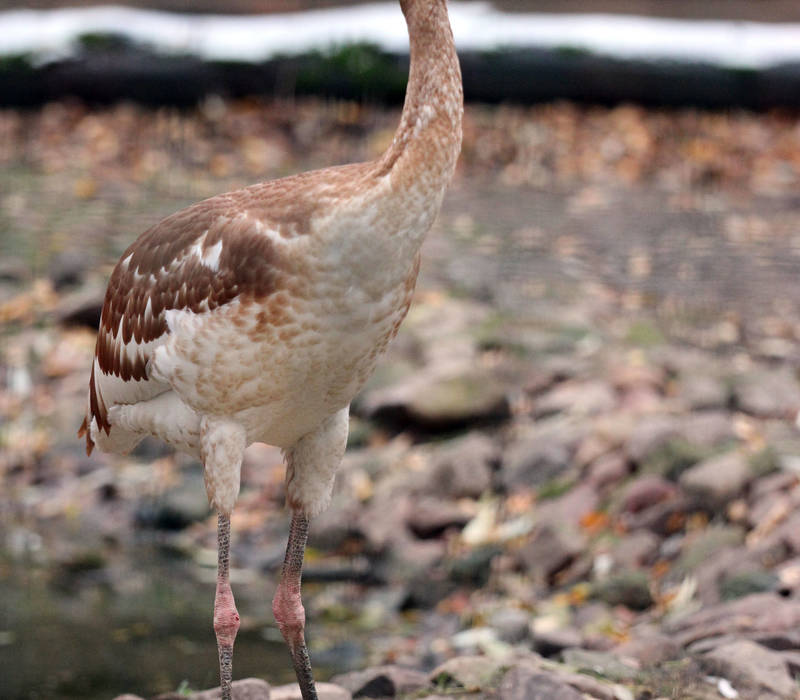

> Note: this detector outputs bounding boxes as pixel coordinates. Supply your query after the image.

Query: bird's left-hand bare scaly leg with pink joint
[214,513,239,700]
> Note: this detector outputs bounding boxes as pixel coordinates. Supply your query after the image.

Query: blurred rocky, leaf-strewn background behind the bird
[0,0,800,699]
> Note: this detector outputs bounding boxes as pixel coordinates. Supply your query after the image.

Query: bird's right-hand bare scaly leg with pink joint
[272,511,317,700]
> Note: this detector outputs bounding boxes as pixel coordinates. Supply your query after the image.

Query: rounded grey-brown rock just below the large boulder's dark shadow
[426,432,500,498]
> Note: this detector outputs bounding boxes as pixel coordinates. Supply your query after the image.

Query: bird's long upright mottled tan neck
[378,0,464,209]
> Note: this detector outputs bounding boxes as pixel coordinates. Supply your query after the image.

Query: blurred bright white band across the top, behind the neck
[0,1,800,69]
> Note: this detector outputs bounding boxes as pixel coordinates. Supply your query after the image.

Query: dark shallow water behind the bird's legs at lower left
[0,548,347,700]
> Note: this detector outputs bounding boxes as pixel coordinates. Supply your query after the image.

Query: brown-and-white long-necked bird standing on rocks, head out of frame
[79,0,463,700]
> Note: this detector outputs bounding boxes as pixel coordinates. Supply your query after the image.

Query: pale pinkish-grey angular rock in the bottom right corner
[699,639,797,698]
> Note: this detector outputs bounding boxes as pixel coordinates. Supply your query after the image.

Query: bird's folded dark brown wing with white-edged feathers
[78,195,290,452]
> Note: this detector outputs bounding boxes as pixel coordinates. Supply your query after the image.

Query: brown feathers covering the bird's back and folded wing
[79,164,369,452]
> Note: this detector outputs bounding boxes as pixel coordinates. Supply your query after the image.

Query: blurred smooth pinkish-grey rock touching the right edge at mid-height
[733,367,800,418]
